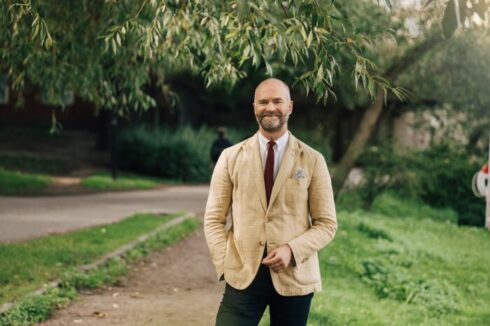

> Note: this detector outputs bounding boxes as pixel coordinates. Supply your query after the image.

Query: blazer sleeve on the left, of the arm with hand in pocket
[204,149,233,280]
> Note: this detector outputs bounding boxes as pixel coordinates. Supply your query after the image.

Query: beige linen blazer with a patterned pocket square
[204,133,337,296]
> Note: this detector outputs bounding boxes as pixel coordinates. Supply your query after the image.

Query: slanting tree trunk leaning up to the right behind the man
[332,33,444,196]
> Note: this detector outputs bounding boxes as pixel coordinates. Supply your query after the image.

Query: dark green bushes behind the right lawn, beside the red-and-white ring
[359,144,485,226]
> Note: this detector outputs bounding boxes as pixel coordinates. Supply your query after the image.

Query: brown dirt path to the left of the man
[42,229,223,326]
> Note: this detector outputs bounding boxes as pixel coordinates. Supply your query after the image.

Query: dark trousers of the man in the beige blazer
[216,265,313,326]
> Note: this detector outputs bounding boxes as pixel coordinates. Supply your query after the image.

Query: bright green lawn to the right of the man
[261,195,490,326]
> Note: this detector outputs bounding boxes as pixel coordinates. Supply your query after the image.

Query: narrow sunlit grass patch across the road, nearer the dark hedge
[81,173,170,190]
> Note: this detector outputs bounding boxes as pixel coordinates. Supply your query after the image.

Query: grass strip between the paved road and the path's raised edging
[0,214,195,304]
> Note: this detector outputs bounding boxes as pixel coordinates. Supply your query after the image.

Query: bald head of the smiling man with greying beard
[253,78,293,133]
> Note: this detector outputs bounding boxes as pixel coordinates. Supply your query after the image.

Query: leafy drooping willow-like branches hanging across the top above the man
[0,0,401,125]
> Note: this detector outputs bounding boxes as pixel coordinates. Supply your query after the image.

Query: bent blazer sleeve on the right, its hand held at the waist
[287,154,337,265]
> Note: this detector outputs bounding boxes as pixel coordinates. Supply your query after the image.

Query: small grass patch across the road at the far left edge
[0,168,52,195]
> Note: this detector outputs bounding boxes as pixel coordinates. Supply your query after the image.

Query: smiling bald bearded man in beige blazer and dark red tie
[204,78,337,326]
